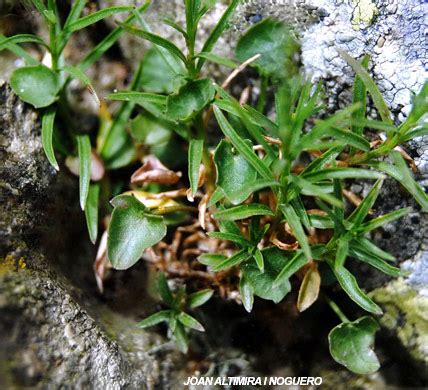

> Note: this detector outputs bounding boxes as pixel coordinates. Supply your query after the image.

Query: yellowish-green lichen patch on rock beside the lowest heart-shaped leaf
[371,279,428,364]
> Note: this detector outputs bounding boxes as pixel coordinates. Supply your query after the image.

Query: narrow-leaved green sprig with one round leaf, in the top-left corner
[0,0,149,222]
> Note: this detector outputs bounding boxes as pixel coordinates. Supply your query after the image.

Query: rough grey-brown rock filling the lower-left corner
[0,83,180,388]
